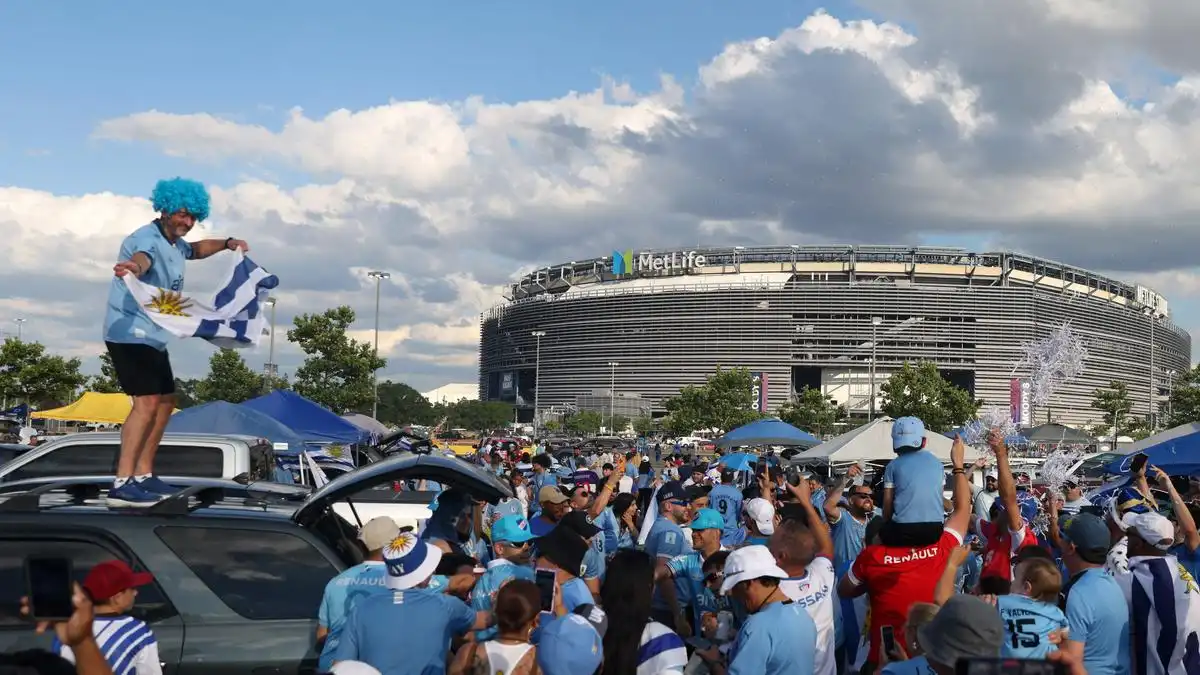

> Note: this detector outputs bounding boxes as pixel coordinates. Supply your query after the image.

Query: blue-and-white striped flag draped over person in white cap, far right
[1117,555,1200,675]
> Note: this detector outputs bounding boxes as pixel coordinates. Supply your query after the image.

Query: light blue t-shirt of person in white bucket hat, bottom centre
[728,602,817,675]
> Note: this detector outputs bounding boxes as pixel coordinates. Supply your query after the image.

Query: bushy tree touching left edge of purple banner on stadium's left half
[662,368,762,436]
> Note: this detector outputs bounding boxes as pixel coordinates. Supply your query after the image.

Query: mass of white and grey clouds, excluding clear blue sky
[0,0,1200,387]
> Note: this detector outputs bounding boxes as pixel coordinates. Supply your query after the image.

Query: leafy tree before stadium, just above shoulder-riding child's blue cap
[880,362,983,431]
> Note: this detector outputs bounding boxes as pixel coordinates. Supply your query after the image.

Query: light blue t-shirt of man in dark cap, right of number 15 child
[1067,568,1129,675]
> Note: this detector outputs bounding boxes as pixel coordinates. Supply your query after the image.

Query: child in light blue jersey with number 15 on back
[996,557,1067,659]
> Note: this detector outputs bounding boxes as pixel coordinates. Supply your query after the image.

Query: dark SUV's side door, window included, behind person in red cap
[0,524,184,675]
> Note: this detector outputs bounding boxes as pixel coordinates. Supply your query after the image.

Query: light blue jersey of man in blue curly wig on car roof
[104,222,192,350]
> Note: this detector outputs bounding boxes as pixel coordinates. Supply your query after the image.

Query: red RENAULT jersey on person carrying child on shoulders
[848,530,962,663]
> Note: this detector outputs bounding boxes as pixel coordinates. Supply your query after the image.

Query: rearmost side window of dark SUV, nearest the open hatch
[157,526,338,621]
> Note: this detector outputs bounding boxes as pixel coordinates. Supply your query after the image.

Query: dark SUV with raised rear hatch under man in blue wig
[0,455,511,675]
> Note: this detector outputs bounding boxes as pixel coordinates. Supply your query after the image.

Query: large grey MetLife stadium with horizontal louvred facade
[479,246,1192,425]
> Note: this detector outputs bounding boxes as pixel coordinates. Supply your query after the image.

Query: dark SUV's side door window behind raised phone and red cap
[0,537,176,628]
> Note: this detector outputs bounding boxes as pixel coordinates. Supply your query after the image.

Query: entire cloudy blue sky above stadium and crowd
[0,0,1200,390]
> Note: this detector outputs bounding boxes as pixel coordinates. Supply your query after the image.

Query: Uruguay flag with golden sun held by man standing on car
[121,251,280,348]
